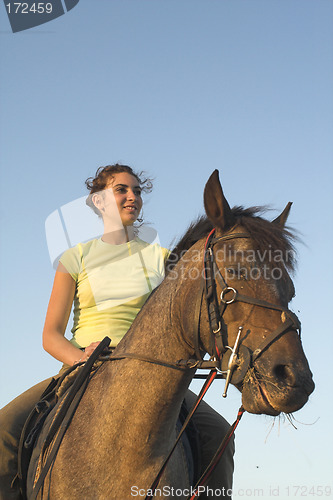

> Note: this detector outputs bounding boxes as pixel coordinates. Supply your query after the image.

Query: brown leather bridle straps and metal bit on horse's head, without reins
[195,229,301,396]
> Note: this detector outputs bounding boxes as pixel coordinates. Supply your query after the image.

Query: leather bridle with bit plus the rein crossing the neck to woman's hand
[107,229,301,390]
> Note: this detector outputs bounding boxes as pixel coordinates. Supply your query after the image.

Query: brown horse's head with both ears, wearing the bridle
[201,170,314,415]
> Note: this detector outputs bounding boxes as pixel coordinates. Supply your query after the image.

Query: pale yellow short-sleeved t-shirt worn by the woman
[60,238,168,348]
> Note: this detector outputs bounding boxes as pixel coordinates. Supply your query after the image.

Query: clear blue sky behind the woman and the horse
[0,0,333,500]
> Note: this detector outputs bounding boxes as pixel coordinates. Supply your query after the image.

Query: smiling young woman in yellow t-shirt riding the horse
[0,164,234,500]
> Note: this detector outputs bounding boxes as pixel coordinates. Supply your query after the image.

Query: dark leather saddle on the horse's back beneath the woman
[17,337,200,500]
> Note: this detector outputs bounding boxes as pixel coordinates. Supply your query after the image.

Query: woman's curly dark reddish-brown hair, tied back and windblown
[85,163,153,217]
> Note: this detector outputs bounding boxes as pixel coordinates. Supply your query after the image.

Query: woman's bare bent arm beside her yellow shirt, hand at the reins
[43,263,98,365]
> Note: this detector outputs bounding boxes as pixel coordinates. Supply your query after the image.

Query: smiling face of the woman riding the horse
[94,172,142,226]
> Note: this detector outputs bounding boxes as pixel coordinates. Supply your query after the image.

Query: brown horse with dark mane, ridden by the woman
[27,170,314,500]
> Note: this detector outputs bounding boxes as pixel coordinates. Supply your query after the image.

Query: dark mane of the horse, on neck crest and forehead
[166,206,298,272]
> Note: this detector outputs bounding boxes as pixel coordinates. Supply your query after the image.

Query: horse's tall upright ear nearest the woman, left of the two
[204,170,234,230]
